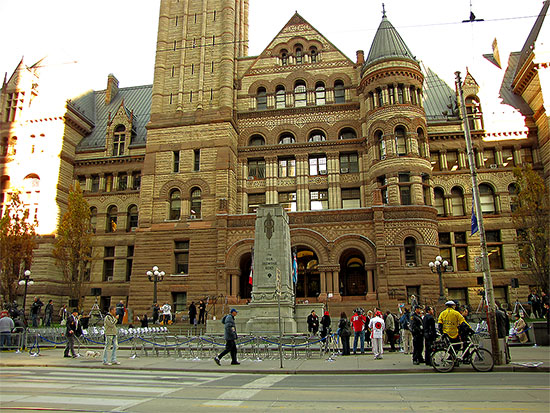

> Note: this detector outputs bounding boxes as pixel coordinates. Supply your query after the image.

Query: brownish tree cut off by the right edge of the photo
[512,165,550,291]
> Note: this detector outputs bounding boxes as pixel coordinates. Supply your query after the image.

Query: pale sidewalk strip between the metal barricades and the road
[0,347,550,374]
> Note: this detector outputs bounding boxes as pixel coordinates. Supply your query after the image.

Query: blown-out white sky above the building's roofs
[0,0,550,128]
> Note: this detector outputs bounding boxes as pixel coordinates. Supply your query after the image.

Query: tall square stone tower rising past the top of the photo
[130,0,248,306]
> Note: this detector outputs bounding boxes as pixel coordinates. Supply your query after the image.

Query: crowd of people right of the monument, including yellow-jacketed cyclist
[307,300,549,365]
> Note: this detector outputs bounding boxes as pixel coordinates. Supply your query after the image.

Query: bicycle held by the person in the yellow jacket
[432,334,495,373]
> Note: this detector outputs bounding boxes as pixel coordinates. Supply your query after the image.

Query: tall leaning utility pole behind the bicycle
[455,72,502,365]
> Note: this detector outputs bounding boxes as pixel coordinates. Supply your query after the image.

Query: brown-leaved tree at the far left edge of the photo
[0,192,37,303]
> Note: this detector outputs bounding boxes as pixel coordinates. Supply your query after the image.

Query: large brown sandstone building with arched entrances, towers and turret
[0,0,550,314]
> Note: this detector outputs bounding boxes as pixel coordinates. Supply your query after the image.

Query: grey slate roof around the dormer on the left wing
[71,85,153,151]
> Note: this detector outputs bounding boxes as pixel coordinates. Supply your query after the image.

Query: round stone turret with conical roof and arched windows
[359,12,431,205]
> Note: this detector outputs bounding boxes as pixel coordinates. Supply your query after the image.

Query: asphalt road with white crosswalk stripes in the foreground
[0,367,550,413]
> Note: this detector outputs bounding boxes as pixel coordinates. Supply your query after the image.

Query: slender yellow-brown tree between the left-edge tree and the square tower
[53,183,93,306]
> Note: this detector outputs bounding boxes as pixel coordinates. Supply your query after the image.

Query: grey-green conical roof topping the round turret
[363,13,416,67]
